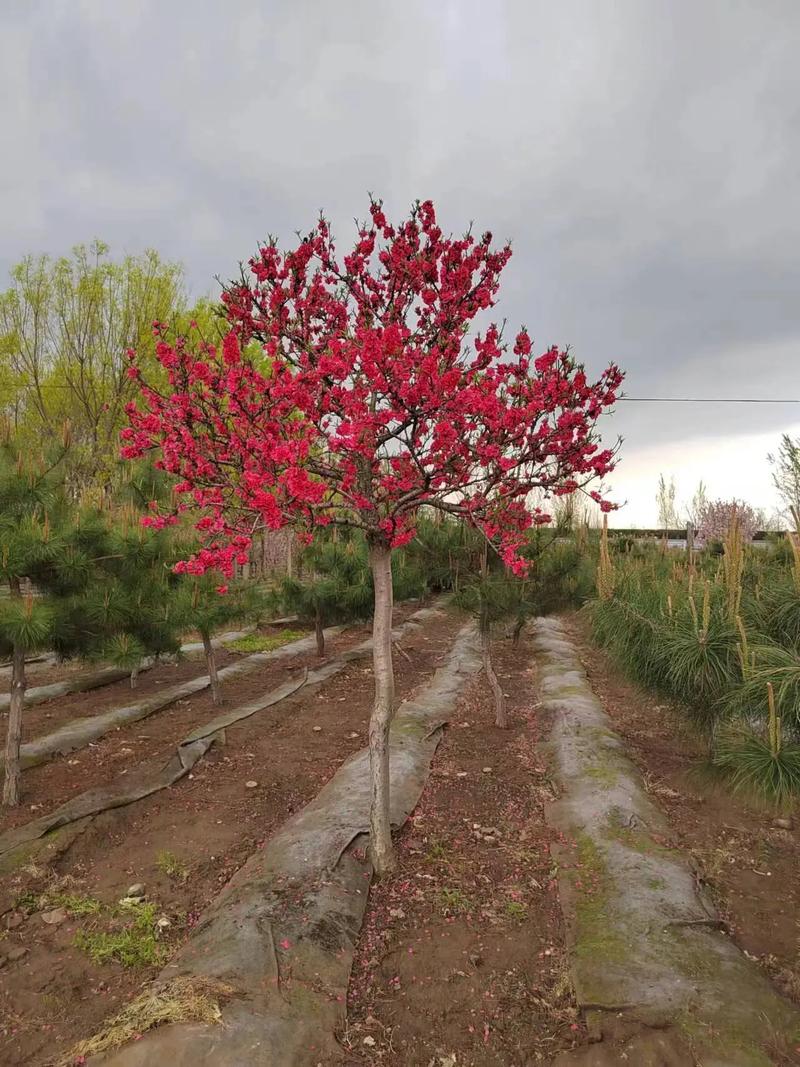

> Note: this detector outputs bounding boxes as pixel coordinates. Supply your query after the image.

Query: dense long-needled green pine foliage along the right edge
[588,533,800,803]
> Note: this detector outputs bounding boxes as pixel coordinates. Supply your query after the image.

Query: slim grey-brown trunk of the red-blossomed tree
[369,543,395,878]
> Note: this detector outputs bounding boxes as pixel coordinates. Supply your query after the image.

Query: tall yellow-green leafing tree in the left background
[0,241,186,488]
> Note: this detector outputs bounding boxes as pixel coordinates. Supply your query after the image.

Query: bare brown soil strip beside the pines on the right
[564,616,800,1003]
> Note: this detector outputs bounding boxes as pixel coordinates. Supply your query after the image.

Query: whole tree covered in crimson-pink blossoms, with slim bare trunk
[123,201,622,874]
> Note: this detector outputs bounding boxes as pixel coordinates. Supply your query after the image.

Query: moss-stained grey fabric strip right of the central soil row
[534,619,800,1067]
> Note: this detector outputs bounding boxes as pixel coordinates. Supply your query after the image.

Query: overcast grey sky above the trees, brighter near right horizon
[0,0,800,525]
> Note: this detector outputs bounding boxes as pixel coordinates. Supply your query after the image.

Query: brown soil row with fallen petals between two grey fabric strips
[340,638,586,1067]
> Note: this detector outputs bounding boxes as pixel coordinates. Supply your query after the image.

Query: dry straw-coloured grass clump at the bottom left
[60,977,235,1067]
